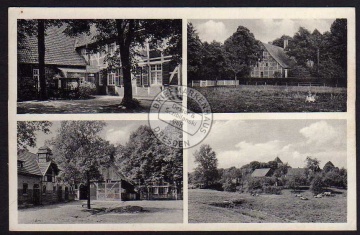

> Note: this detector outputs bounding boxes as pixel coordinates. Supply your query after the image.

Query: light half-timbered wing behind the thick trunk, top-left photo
[76,35,181,97]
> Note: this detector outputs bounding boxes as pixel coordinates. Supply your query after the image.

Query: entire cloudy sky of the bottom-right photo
[188,119,346,172]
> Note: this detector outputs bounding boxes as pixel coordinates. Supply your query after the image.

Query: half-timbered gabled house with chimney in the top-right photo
[250,40,294,78]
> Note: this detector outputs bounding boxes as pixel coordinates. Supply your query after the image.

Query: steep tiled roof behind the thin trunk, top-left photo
[17,26,86,66]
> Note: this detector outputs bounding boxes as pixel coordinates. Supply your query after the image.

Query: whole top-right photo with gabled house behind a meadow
[187,19,348,113]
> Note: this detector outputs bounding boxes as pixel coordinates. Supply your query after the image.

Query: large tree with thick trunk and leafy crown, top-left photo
[65,19,182,108]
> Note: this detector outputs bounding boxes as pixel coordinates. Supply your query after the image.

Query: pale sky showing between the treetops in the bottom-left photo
[29,121,148,153]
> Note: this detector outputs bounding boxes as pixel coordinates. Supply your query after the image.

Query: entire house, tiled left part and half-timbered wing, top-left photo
[18,23,181,100]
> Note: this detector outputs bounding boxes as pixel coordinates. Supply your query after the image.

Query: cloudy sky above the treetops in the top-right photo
[189,19,335,43]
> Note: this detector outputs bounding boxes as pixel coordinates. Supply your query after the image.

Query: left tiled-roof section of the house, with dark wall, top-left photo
[17,26,86,100]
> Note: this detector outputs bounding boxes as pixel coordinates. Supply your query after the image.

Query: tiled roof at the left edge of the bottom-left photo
[18,150,43,176]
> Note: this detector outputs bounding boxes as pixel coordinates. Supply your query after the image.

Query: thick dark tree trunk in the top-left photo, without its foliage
[116,20,133,107]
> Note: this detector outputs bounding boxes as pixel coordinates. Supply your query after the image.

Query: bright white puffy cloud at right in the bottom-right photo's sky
[300,121,339,145]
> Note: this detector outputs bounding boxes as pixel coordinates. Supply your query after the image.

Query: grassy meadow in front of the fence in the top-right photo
[188,85,347,113]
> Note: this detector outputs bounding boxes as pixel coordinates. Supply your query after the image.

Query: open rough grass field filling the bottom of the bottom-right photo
[189,189,347,223]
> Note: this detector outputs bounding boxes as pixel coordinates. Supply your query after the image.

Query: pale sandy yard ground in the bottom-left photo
[18,200,183,224]
